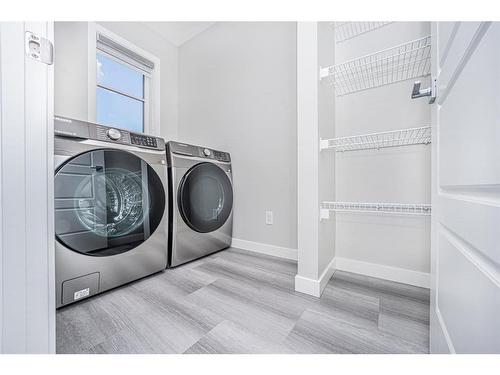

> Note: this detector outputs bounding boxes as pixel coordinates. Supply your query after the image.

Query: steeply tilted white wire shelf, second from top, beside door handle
[320,36,431,96]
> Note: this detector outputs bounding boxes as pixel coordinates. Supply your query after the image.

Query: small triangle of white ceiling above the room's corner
[144,22,215,46]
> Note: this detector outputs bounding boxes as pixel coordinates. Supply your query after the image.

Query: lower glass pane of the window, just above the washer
[96,87,144,133]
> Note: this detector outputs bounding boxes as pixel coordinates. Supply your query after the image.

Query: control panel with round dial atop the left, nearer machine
[54,116,165,150]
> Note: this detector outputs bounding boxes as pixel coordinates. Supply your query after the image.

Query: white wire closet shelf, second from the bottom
[320,126,431,152]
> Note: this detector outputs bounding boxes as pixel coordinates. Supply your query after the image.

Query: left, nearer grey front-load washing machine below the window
[54,116,168,307]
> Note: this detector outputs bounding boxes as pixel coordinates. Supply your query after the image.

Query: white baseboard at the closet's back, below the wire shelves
[336,257,430,288]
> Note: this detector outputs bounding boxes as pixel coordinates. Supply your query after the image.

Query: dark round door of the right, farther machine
[178,163,233,233]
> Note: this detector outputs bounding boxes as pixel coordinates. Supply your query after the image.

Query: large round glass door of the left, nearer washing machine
[54,150,165,256]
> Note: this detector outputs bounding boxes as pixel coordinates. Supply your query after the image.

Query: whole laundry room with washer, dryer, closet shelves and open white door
[0,4,500,368]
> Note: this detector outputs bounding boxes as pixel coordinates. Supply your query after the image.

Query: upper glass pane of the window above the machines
[97,53,144,99]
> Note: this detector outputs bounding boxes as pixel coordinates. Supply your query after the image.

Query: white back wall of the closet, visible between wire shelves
[335,22,431,273]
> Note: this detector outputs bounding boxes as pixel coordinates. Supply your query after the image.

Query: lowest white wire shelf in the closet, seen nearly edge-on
[320,202,431,219]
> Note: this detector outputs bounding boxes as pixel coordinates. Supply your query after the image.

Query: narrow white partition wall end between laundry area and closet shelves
[295,22,335,297]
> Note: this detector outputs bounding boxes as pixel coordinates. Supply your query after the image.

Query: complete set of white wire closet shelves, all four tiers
[319,27,431,220]
